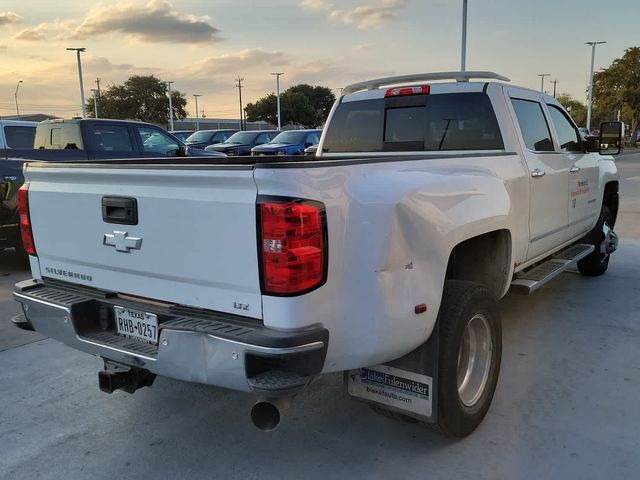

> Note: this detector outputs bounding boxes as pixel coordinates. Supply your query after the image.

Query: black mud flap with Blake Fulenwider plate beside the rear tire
[344,322,439,423]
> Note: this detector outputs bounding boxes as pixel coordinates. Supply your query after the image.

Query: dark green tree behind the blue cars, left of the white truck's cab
[245,84,336,128]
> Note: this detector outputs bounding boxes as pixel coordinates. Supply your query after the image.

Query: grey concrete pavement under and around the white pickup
[0,155,640,479]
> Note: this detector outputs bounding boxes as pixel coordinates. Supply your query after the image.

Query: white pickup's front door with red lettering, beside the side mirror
[547,104,602,237]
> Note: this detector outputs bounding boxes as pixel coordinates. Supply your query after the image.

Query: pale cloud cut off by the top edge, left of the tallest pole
[302,0,408,29]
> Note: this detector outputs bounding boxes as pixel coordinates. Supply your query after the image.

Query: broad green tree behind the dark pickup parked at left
[87,75,187,125]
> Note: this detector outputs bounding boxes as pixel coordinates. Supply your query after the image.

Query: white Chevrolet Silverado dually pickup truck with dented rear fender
[14,72,620,436]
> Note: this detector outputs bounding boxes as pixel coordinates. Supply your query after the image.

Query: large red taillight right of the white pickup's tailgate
[258,197,327,295]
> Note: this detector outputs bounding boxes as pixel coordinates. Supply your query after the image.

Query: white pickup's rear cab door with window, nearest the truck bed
[508,89,571,260]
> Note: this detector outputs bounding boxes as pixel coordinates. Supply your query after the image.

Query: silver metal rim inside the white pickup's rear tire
[457,314,493,407]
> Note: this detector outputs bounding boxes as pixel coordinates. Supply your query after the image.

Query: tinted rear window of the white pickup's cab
[323,92,504,152]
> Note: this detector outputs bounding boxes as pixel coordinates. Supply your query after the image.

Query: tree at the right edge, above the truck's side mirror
[593,47,640,145]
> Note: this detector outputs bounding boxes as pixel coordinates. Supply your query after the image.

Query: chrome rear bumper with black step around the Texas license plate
[14,280,329,395]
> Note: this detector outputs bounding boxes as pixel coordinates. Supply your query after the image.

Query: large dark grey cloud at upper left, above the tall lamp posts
[69,0,221,43]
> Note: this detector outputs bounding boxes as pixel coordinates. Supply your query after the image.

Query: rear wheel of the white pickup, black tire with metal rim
[438,280,502,437]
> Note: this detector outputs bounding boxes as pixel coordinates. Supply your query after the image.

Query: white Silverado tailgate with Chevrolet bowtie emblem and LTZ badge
[25,164,262,318]
